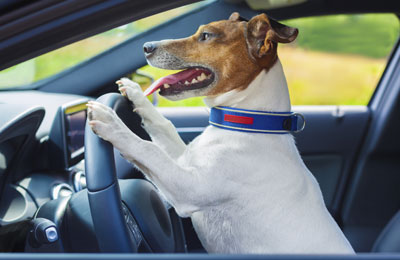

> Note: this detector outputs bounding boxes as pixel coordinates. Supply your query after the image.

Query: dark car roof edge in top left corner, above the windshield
[0,0,202,70]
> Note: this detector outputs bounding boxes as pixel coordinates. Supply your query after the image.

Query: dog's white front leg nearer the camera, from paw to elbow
[88,101,207,217]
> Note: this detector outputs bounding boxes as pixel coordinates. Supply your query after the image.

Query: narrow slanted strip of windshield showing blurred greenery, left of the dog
[0,3,201,89]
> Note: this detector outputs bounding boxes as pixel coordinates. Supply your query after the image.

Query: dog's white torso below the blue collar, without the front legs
[180,127,351,253]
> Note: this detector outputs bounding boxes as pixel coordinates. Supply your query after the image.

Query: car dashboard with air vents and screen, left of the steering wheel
[0,91,90,225]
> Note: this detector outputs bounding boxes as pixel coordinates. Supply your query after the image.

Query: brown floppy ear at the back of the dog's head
[245,14,299,58]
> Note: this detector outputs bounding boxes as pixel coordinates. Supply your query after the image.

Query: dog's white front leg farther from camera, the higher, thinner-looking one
[117,78,186,158]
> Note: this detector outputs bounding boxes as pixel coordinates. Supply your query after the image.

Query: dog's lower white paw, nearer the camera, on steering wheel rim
[87,101,126,142]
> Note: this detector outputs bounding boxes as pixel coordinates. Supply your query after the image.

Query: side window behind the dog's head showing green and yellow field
[130,14,399,106]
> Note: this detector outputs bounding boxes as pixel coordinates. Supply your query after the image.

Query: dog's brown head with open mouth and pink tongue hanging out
[143,13,298,100]
